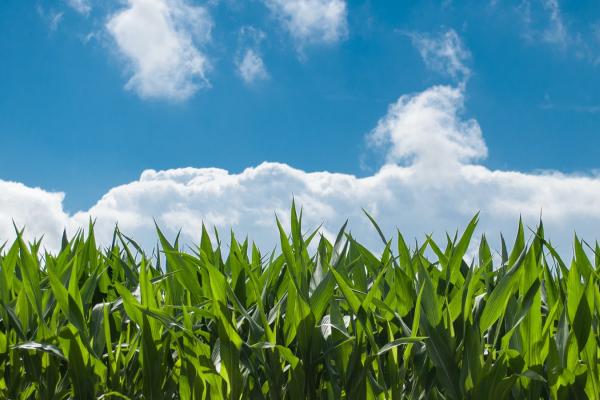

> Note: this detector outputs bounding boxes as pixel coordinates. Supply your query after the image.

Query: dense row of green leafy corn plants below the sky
[0,208,600,400]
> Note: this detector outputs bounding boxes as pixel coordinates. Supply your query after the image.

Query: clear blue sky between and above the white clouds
[0,0,600,211]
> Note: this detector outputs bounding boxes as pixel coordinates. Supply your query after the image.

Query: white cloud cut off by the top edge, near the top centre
[264,0,348,46]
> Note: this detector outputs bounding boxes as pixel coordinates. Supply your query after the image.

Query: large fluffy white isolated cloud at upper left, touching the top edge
[106,0,213,100]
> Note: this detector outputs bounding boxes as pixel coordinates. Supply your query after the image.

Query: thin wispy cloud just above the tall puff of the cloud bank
[409,29,471,80]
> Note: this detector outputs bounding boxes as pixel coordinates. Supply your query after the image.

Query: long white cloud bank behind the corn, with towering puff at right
[0,86,600,254]
